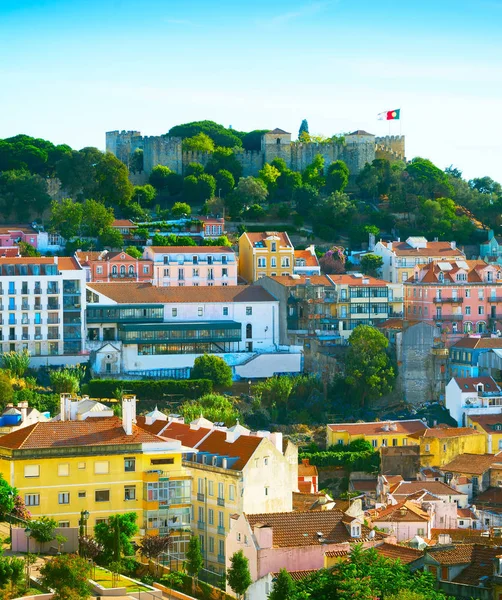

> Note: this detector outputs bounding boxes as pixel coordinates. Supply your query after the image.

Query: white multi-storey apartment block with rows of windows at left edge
[0,256,85,364]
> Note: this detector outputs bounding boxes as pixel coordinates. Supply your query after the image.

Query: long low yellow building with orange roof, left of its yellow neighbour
[326,419,427,448]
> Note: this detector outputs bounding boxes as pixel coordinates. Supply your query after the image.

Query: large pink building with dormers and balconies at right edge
[404,260,502,343]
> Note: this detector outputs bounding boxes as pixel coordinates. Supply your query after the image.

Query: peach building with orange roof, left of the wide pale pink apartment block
[75,250,153,283]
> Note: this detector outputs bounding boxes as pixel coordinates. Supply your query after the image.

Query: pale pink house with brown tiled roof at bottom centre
[225,508,386,600]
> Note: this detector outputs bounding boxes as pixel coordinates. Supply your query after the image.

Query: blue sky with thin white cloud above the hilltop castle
[0,0,502,181]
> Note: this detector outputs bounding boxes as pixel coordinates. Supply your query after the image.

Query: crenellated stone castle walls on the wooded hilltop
[106,129,405,177]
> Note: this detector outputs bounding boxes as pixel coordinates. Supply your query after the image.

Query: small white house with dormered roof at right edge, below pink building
[446,376,502,426]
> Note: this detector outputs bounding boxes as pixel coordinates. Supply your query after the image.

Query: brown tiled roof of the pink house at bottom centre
[245,508,386,548]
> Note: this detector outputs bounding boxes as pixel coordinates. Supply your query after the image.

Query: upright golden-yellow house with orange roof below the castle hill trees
[239,231,295,283]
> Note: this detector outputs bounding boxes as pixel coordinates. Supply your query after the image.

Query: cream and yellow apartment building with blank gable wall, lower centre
[138,411,298,573]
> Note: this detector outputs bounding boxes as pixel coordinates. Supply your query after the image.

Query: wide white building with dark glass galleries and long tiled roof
[87,283,300,377]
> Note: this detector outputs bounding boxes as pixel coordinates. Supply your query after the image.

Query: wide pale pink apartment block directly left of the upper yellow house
[143,246,237,287]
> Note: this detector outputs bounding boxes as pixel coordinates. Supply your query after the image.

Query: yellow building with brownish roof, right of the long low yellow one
[412,427,486,467]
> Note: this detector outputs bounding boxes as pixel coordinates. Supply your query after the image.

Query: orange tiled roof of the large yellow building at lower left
[0,417,170,450]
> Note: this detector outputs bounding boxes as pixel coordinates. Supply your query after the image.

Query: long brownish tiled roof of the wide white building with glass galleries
[87,282,275,304]
